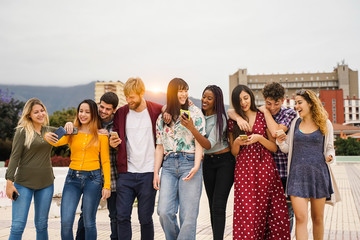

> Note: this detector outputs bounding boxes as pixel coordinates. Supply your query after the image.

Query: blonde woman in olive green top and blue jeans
[5,98,54,240]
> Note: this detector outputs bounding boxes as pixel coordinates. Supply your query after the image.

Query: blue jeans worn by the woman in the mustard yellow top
[61,169,102,240]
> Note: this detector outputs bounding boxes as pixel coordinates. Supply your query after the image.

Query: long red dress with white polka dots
[228,112,290,240]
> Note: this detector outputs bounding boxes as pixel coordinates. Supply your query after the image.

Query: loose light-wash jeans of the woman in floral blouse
[157,152,202,240]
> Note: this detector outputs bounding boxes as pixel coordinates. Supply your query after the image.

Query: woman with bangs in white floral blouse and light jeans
[153,78,205,240]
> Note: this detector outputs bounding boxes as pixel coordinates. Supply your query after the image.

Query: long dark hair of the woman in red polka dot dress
[231,85,258,140]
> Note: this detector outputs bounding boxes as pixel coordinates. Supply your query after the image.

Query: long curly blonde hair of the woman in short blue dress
[296,89,329,135]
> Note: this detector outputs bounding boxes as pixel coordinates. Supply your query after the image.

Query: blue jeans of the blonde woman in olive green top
[9,183,54,240]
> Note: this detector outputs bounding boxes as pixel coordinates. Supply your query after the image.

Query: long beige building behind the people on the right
[229,63,359,105]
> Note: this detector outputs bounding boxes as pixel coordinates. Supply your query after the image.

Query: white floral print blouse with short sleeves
[156,105,206,155]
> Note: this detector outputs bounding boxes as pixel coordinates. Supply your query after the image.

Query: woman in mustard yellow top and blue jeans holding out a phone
[45,99,111,240]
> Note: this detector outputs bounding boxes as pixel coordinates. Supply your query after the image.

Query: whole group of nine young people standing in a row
[6,78,338,240]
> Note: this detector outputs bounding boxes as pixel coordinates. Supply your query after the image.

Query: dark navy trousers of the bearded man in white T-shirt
[116,172,156,240]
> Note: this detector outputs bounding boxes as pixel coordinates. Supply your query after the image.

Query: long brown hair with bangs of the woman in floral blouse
[165,78,189,122]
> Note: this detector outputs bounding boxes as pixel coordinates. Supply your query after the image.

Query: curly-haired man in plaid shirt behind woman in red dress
[228,82,296,231]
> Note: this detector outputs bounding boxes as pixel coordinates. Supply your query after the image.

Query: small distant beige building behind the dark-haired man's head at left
[95,80,127,107]
